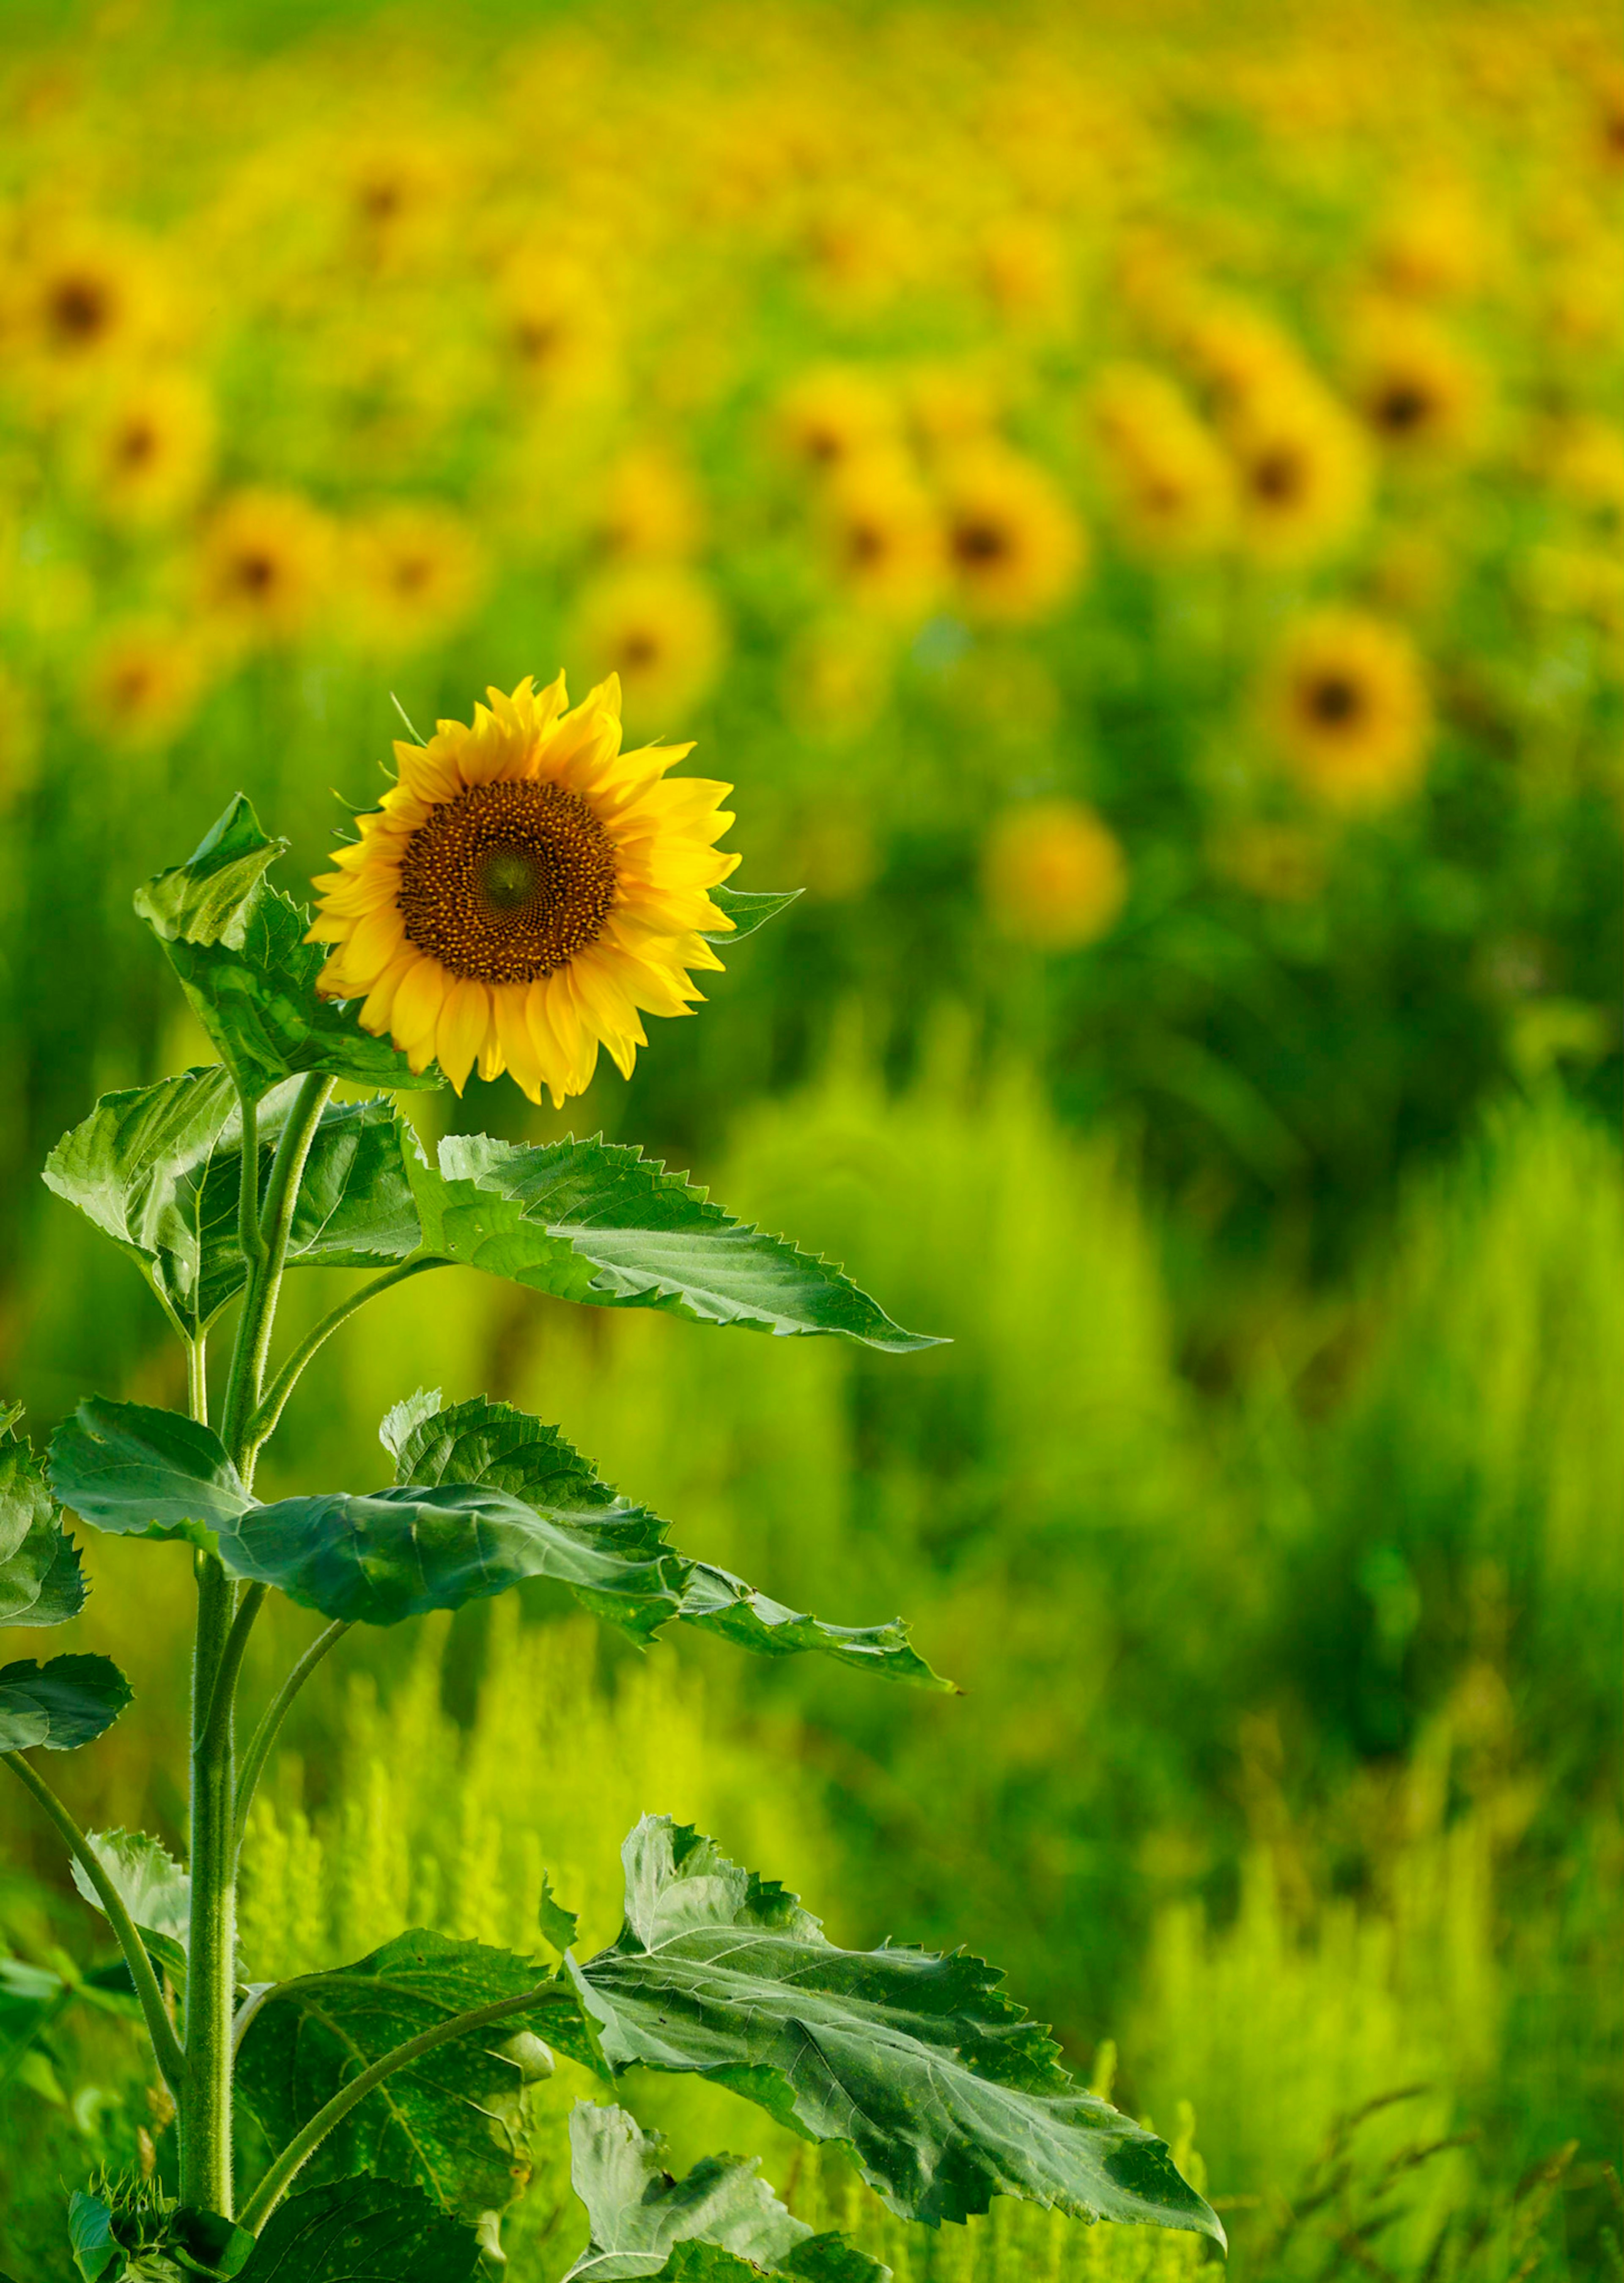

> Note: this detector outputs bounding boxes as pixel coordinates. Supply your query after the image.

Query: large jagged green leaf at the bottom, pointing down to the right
[566,1817,1224,2242]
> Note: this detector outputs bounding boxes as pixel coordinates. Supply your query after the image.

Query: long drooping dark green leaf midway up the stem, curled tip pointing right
[219,1397,948,1687]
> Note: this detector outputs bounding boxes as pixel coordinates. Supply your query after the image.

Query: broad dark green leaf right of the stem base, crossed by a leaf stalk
[238,1929,596,2217]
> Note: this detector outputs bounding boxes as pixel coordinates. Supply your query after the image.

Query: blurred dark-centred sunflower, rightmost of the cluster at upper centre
[941,445,1087,626]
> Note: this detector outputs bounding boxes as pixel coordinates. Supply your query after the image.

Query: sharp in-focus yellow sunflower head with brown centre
[308,673,738,1107]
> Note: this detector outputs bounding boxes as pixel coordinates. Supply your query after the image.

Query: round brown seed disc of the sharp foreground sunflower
[400,781,617,984]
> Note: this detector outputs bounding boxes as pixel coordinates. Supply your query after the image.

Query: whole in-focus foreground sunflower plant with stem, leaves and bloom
[0,676,1222,2283]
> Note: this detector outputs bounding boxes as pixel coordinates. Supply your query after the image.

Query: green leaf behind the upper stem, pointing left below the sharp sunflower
[46,1068,418,1340]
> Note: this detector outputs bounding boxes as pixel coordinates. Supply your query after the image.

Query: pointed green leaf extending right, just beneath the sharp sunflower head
[406,1135,939,1354]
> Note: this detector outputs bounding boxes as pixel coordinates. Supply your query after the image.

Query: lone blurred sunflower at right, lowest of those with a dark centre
[1263,609,1432,808]
